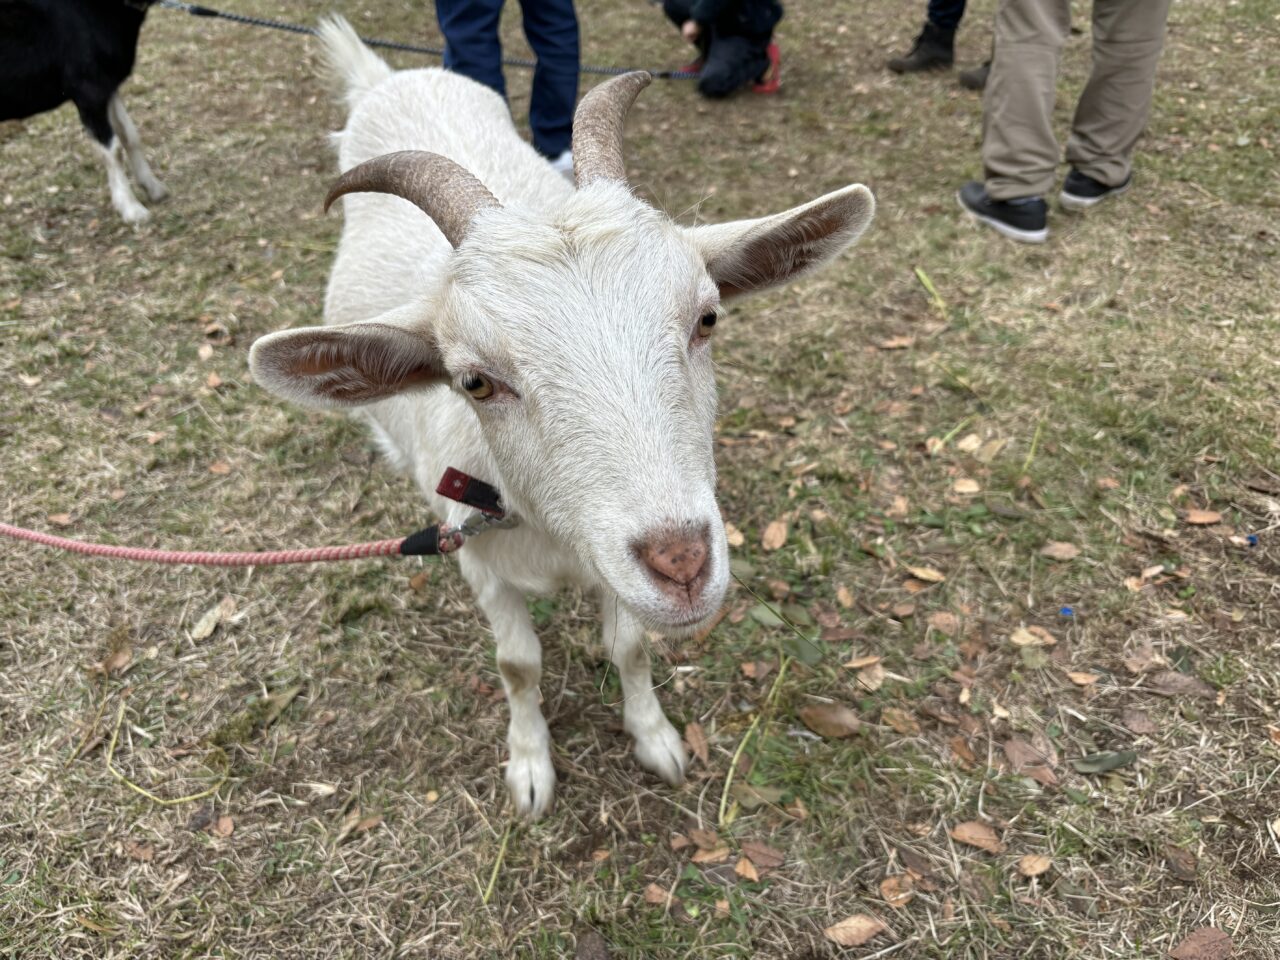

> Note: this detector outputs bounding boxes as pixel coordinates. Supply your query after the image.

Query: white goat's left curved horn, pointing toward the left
[324,150,502,247]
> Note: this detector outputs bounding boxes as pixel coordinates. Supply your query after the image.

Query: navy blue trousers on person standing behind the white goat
[435,0,579,157]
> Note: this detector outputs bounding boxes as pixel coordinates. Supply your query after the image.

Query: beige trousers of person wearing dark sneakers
[982,0,1170,200]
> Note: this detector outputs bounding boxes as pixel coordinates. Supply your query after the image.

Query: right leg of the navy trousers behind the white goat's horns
[520,0,579,160]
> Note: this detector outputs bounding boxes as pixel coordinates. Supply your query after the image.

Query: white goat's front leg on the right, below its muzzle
[600,591,689,786]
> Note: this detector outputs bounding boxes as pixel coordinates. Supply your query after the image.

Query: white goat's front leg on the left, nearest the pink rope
[460,552,556,817]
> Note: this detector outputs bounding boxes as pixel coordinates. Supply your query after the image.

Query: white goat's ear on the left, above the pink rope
[248,311,448,407]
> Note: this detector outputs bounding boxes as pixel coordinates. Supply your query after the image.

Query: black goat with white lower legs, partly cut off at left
[0,0,169,223]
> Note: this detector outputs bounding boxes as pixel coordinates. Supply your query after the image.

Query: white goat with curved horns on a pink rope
[250,20,874,815]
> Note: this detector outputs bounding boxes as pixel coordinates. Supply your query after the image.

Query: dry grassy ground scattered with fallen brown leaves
[0,0,1280,960]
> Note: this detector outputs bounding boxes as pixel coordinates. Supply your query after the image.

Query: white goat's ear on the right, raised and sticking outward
[689,184,876,300]
